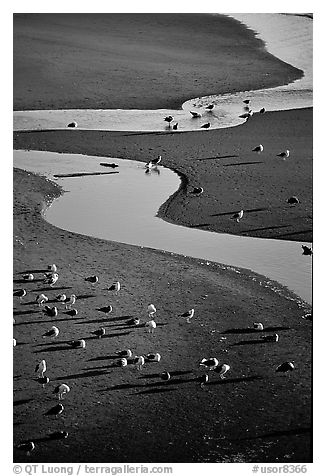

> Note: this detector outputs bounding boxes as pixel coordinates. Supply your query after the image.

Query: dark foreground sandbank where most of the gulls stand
[14,165,311,463]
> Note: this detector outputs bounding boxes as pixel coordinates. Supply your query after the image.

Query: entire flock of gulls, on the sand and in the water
[13,99,312,455]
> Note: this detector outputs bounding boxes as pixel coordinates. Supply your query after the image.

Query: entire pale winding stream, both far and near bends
[14,14,312,303]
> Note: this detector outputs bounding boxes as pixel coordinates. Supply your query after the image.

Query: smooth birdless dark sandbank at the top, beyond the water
[14,14,301,110]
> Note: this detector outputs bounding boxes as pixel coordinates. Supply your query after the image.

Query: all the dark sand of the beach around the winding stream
[13,14,312,463]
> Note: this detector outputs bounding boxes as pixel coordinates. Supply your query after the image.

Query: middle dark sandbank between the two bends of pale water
[14,109,312,242]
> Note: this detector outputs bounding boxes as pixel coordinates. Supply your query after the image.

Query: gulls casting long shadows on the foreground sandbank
[13,256,312,456]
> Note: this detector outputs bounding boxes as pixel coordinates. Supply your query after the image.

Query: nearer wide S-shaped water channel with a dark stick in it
[14,150,312,303]
